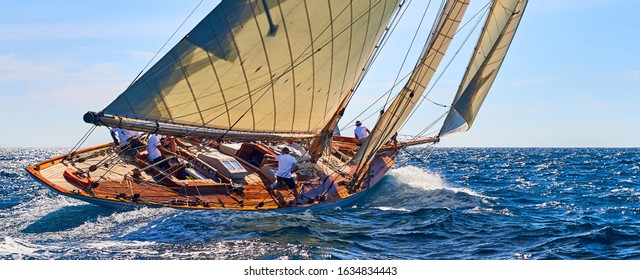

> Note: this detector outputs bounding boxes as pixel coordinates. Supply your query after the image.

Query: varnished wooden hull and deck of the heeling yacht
[26,137,397,212]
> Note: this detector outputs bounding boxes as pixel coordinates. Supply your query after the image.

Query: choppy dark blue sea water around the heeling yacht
[0,148,640,260]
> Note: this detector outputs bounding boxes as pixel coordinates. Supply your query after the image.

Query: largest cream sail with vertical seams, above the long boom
[101,0,400,138]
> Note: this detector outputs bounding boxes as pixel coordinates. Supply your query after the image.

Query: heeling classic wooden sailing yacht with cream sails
[26,0,527,211]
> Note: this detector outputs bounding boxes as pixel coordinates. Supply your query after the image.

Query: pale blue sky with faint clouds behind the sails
[0,0,640,147]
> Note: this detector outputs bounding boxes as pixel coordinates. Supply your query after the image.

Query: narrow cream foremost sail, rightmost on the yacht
[440,0,527,136]
